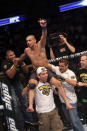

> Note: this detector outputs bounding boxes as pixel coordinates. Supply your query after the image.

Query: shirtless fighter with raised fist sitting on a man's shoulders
[20,19,73,112]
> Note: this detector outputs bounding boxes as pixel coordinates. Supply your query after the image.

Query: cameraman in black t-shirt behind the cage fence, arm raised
[50,33,75,59]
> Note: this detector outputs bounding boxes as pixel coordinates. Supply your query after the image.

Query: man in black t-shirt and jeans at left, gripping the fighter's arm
[1,50,33,131]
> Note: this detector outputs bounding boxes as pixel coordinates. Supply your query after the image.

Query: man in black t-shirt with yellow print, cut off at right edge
[77,54,87,122]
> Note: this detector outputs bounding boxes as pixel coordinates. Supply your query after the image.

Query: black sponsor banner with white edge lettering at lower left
[0,82,19,131]
